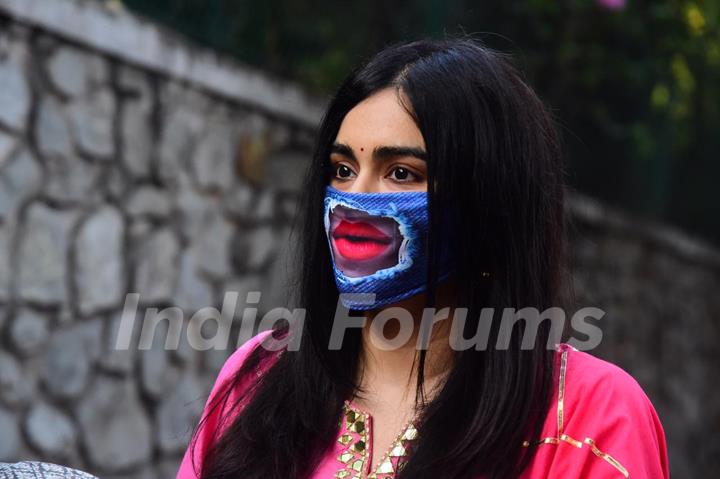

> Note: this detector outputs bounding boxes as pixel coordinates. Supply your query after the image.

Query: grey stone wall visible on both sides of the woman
[0,0,720,478]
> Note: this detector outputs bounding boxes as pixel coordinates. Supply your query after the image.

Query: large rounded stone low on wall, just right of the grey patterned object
[77,376,153,473]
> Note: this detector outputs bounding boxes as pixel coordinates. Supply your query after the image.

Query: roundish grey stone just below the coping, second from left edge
[47,46,108,97]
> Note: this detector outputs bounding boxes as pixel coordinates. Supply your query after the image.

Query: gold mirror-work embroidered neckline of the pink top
[334,401,417,479]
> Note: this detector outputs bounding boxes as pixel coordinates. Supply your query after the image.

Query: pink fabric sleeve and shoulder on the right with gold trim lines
[540,351,670,479]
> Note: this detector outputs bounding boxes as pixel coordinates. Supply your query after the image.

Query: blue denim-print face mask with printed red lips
[324,186,451,310]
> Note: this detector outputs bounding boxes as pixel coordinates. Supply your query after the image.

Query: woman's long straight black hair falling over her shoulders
[195,37,565,479]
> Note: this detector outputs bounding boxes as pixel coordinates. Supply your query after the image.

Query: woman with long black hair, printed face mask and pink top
[178,39,668,479]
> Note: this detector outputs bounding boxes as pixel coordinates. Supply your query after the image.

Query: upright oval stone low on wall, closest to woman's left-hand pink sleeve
[156,375,207,454]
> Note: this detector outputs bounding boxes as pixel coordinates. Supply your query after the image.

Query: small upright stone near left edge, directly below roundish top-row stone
[35,95,73,156]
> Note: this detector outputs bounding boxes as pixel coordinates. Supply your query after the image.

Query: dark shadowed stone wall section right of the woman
[569,196,720,478]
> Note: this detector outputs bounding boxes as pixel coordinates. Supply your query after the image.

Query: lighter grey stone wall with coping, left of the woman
[0,0,320,478]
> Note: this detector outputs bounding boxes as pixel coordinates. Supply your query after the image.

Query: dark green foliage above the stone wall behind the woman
[121,0,720,246]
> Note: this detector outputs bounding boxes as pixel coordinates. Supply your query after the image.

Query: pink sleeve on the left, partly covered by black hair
[177,331,271,479]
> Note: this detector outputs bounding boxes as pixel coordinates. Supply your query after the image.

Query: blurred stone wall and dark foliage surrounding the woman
[0,0,720,478]
